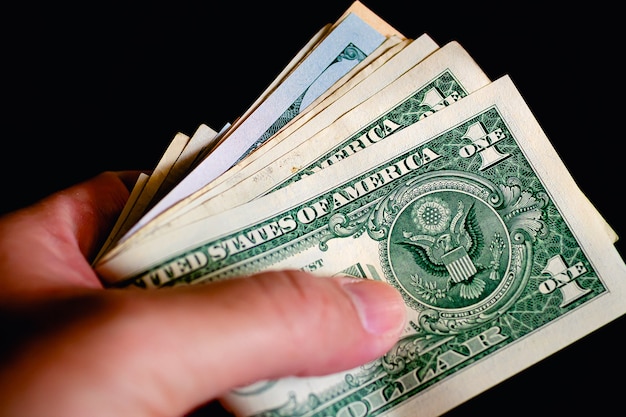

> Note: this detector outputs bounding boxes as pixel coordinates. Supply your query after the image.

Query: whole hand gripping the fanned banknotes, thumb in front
[0,172,405,417]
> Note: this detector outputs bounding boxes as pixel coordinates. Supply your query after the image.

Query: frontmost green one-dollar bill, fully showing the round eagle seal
[96,76,626,417]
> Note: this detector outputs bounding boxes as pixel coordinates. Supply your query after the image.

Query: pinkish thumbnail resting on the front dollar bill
[341,278,406,335]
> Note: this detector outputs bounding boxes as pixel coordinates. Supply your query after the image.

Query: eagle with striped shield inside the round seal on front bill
[396,196,485,299]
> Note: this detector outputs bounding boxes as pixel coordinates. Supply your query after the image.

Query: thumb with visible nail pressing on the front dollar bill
[1,271,405,416]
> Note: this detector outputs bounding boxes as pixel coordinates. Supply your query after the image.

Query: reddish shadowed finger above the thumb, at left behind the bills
[0,171,138,292]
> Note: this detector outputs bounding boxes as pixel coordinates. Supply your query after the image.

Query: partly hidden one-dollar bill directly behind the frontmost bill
[106,42,482,256]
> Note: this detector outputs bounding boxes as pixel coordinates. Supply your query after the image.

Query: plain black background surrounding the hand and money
[0,0,626,416]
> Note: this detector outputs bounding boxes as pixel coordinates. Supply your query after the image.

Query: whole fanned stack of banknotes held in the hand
[94,1,626,416]
